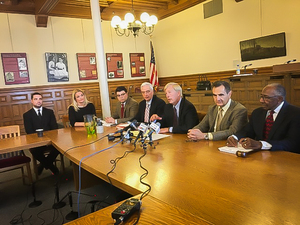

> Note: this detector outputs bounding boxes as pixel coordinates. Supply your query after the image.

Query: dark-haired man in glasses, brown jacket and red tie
[105,86,139,124]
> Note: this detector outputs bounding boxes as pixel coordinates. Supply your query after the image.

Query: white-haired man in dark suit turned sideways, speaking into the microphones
[150,82,199,134]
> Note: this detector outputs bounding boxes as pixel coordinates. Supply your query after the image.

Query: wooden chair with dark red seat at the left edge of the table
[0,125,32,184]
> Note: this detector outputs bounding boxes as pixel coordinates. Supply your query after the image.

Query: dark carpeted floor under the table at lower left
[0,156,130,225]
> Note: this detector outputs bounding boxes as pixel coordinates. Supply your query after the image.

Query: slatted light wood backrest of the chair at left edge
[0,125,23,159]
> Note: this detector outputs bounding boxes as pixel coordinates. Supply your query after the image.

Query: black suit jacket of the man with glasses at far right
[236,102,300,153]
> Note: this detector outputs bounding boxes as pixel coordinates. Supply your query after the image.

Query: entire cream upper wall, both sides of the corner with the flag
[0,0,300,88]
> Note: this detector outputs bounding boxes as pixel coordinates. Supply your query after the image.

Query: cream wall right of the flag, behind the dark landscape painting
[153,0,300,77]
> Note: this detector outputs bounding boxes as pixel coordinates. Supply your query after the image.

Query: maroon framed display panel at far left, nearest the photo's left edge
[1,53,30,85]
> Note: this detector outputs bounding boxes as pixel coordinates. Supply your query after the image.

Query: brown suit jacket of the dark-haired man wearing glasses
[112,97,139,123]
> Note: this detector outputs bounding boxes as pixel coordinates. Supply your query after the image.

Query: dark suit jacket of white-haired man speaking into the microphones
[161,98,199,134]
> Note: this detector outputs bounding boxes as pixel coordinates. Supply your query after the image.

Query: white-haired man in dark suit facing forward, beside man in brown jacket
[134,82,166,123]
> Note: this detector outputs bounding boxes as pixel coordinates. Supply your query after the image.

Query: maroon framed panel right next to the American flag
[129,53,146,77]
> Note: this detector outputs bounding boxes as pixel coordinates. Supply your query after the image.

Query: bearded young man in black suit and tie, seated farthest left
[23,92,59,175]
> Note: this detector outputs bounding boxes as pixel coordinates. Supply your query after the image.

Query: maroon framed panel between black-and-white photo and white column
[76,53,98,80]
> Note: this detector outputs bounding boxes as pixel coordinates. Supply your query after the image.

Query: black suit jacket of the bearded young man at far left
[23,107,58,134]
